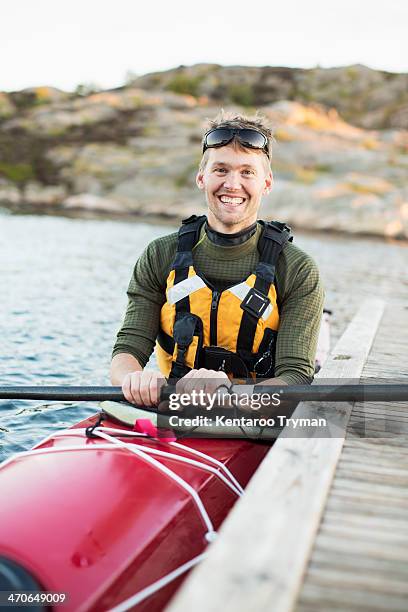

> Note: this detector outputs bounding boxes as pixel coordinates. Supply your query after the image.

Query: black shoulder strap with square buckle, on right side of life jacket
[237,221,293,361]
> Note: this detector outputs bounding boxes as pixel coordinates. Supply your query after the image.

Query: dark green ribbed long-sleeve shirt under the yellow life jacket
[113,224,323,384]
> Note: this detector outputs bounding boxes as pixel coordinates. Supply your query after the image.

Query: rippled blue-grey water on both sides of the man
[0,215,408,461]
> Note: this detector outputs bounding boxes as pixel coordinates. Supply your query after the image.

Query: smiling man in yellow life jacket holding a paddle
[111,115,323,406]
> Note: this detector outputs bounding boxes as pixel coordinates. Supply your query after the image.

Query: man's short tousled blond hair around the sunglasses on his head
[199,109,273,172]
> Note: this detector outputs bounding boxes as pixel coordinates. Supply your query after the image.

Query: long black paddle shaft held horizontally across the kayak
[0,383,408,402]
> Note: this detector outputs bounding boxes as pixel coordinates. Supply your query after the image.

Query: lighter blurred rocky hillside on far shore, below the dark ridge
[0,64,408,240]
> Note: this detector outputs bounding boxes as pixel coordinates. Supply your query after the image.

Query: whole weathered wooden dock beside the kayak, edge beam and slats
[168,300,408,612]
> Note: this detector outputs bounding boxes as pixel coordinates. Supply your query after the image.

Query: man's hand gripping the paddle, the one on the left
[122,370,166,406]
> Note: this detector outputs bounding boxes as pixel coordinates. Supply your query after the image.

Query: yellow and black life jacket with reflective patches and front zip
[156,215,292,378]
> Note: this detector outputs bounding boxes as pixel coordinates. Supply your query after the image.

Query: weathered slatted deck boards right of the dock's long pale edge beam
[296,303,408,612]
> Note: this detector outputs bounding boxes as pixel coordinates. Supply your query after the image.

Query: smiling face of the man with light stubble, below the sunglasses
[196,145,273,234]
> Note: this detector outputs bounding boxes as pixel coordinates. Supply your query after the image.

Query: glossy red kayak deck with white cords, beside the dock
[0,406,270,612]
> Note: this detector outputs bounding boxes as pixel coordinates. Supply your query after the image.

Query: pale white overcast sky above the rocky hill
[0,0,408,91]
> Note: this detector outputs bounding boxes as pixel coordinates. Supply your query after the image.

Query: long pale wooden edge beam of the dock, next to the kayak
[168,299,384,612]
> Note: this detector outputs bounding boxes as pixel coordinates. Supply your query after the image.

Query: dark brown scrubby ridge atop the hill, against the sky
[133,64,408,129]
